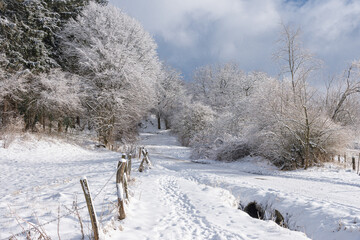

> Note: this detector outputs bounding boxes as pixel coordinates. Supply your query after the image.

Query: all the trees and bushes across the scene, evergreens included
[0,0,360,169]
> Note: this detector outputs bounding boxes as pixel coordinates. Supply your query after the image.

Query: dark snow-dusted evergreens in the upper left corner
[0,0,106,73]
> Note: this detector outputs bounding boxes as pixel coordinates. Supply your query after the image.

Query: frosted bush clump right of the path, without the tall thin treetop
[178,58,351,169]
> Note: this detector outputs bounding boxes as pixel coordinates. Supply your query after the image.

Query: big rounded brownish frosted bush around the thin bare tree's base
[248,80,349,169]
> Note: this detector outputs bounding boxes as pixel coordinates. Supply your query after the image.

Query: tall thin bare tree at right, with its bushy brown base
[255,25,347,169]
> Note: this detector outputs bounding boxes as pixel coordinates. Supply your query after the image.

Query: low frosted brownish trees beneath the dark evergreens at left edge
[0,68,82,130]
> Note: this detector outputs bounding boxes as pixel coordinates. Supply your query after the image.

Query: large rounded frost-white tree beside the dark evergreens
[61,3,161,144]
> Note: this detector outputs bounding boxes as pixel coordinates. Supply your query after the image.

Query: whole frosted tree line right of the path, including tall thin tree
[160,25,360,169]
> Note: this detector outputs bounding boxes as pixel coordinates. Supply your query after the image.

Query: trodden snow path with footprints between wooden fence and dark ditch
[105,131,307,240]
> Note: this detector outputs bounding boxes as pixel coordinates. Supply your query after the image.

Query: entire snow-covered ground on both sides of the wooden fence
[0,128,360,240]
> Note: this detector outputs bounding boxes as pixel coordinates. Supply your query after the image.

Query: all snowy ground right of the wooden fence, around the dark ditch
[111,131,360,240]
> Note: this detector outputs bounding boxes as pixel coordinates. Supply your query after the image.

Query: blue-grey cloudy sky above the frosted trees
[110,0,360,80]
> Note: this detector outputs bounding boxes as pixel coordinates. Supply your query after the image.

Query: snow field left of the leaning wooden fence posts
[0,136,121,239]
